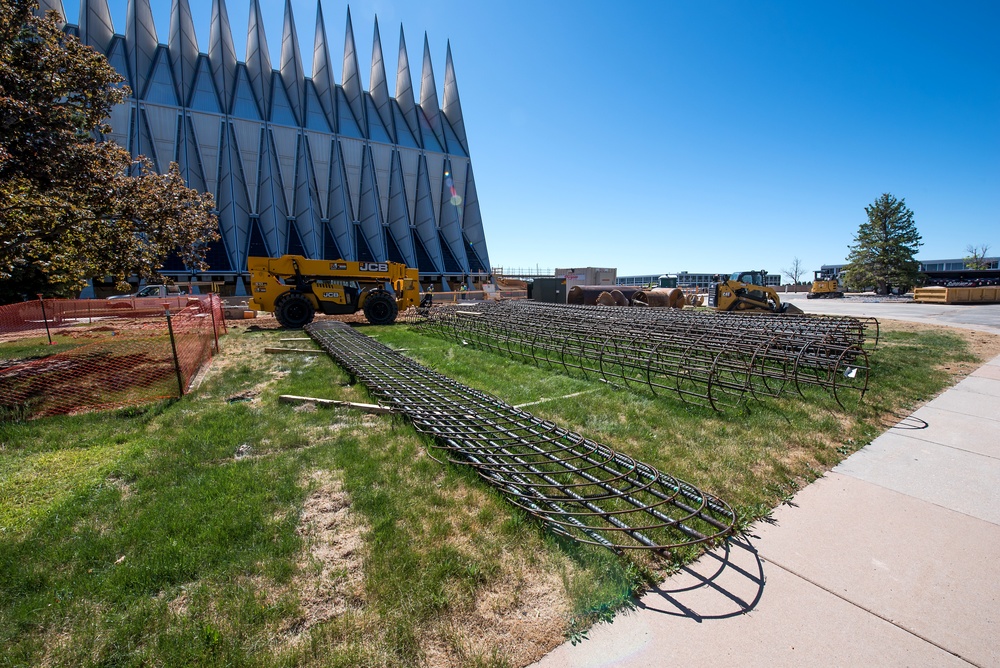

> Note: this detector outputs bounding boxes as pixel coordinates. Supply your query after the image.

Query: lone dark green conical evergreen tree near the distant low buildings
[844,193,922,295]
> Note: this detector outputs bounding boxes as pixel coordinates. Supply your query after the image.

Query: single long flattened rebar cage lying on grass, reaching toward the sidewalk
[305,321,736,551]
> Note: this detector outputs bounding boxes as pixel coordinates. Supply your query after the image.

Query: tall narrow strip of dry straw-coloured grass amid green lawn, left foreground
[285,471,367,641]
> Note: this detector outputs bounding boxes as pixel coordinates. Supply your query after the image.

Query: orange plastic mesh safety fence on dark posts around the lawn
[0,294,226,420]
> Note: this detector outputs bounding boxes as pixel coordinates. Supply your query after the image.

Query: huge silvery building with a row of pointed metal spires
[40,0,490,294]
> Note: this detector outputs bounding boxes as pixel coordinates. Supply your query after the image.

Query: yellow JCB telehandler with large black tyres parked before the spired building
[247,255,420,329]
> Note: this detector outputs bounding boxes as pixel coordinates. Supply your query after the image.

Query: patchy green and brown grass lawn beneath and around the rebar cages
[0,319,996,667]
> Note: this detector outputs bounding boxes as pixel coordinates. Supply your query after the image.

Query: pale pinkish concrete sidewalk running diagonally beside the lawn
[534,357,1000,668]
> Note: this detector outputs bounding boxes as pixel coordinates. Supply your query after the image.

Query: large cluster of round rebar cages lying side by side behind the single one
[425,301,869,410]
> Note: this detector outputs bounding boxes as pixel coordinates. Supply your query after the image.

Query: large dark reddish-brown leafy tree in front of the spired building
[0,0,218,294]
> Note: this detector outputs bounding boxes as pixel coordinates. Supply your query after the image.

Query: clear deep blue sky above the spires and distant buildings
[65,0,1000,276]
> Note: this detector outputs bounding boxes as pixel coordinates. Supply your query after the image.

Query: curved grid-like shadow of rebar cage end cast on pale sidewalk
[636,538,764,623]
